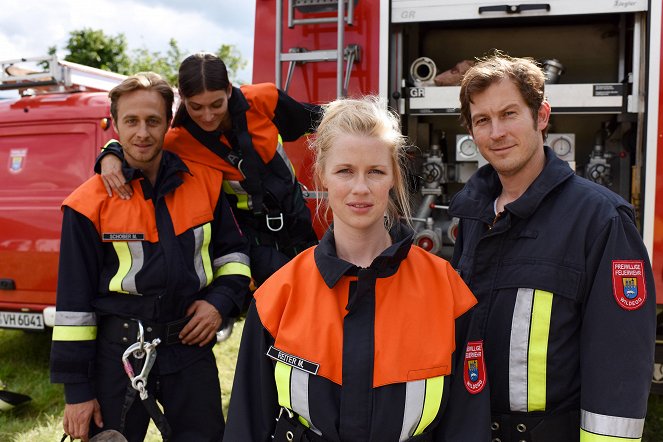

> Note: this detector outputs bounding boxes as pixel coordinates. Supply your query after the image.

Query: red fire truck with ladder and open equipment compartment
[253,0,663,388]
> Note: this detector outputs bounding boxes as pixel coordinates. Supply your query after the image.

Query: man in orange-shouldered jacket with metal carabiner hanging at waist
[51,72,250,441]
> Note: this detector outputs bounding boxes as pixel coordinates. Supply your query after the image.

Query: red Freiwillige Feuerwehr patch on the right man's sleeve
[612,260,647,310]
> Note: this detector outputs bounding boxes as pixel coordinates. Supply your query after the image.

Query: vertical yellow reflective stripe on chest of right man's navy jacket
[527,290,553,411]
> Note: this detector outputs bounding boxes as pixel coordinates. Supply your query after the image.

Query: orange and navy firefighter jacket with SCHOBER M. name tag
[51,151,250,403]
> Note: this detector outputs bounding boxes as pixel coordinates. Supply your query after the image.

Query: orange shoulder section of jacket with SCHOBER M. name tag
[62,162,223,242]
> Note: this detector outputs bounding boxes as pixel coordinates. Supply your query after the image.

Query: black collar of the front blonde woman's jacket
[313,224,414,288]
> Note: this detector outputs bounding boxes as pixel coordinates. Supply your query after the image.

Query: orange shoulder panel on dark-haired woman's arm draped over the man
[163,126,244,181]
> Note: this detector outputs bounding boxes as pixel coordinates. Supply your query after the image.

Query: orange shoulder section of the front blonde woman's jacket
[255,247,476,387]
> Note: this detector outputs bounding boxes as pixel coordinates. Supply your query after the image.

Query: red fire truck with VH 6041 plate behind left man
[0,57,125,330]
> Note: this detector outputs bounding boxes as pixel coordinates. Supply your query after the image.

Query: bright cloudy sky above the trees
[0,0,256,83]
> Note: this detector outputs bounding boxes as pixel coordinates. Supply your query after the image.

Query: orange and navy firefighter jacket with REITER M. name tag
[224,226,476,442]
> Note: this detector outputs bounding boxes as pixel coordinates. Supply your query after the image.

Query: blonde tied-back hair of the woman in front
[309,96,410,229]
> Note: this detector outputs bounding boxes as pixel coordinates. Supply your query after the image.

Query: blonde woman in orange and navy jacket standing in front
[224,97,476,442]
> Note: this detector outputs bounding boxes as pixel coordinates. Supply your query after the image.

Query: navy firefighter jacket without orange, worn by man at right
[450,147,656,442]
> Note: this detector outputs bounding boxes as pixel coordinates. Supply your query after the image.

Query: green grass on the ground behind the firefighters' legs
[0,322,663,442]
